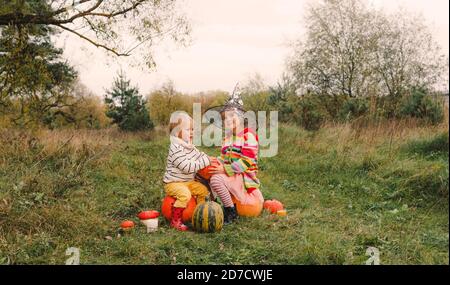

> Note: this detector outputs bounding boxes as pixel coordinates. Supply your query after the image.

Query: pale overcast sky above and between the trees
[60,0,449,95]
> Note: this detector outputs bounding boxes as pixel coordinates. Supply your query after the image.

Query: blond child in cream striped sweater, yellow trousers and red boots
[163,112,216,231]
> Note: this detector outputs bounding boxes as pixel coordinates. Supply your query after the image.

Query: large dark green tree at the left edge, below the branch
[0,12,77,125]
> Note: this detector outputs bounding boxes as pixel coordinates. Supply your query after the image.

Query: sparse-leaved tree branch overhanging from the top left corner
[0,0,189,67]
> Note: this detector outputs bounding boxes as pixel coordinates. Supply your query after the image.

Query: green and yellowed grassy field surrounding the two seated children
[0,122,449,264]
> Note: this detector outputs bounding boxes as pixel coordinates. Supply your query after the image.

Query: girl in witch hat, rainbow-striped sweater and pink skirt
[210,85,264,224]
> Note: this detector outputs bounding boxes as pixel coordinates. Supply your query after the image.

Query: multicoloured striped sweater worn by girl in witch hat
[219,128,260,192]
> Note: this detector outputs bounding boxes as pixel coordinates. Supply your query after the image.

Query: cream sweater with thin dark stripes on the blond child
[163,136,211,183]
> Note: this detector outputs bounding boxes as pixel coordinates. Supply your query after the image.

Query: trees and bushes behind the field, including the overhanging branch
[0,0,448,131]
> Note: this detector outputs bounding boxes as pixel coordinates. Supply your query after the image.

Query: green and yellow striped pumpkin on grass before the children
[192,202,223,233]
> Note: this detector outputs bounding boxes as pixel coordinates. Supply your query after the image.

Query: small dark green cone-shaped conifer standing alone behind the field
[105,72,153,131]
